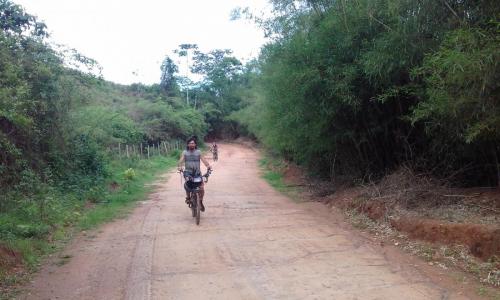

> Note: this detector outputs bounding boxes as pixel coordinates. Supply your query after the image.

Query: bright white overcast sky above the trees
[14,0,267,84]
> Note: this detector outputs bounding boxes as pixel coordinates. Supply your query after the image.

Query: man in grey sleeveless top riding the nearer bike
[177,136,212,211]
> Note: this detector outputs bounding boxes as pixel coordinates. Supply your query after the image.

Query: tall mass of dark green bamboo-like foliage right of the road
[232,0,500,185]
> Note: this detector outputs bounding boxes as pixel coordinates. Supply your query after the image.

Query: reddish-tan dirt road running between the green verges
[21,145,474,299]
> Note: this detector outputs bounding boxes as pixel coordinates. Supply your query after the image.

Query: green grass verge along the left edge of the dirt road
[0,153,177,299]
